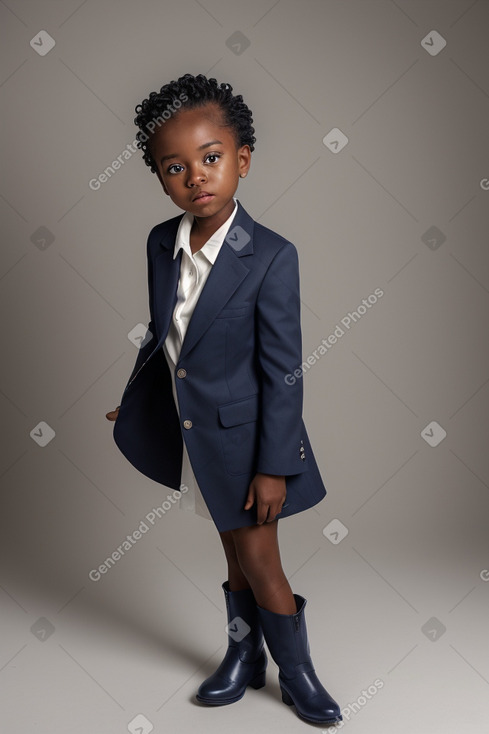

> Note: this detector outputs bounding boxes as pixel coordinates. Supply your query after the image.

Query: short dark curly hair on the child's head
[134,74,256,173]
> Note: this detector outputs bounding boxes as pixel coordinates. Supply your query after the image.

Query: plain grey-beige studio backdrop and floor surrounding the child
[0,0,489,734]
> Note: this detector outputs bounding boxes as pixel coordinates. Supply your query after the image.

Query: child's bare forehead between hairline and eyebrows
[149,104,234,155]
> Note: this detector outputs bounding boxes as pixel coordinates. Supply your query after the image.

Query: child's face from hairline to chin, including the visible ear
[149,104,251,221]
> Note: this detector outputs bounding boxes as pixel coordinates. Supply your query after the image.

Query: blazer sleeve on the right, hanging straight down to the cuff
[256,242,307,475]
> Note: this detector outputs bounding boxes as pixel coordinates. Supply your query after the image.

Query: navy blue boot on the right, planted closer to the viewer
[257,594,343,724]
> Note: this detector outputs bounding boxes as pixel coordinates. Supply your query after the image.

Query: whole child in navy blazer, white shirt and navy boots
[107,74,342,724]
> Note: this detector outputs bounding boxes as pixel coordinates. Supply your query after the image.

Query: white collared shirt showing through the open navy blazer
[162,199,238,520]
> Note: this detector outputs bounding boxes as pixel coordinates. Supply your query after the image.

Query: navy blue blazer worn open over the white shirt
[113,202,326,532]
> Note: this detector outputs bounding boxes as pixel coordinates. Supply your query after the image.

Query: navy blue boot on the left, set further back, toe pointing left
[196,581,268,706]
